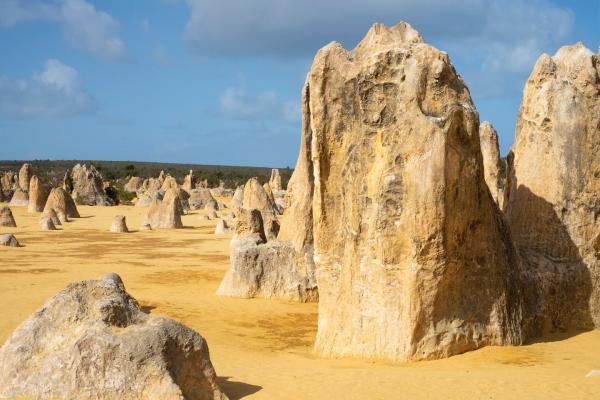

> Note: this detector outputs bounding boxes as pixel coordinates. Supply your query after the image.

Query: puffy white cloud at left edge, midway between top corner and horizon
[0,59,94,118]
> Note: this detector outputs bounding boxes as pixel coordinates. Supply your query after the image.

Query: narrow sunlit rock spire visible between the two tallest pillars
[479,121,504,208]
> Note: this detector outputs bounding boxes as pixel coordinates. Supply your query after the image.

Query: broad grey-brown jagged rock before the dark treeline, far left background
[71,164,114,206]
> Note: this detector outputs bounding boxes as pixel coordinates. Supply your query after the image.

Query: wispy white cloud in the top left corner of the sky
[0,0,127,61]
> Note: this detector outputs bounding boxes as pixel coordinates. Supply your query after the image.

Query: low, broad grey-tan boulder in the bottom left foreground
[0,274,227,400]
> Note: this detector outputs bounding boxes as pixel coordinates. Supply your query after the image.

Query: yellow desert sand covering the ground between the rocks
[0,206,600,400]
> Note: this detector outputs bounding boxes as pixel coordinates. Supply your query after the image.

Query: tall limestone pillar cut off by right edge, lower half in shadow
[505,43,600,336]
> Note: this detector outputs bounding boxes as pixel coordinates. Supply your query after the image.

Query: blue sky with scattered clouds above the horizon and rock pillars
[0,0,600,167]
